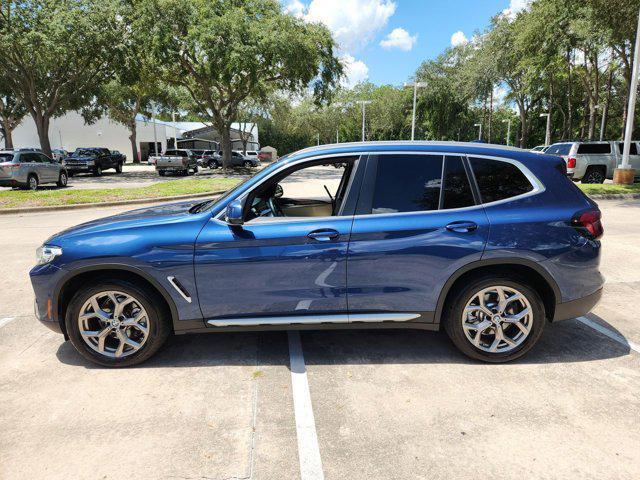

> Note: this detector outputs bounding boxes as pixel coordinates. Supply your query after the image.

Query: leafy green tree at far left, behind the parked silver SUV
[0,0,124,155]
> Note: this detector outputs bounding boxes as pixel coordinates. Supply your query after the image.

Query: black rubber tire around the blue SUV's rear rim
[443,275,547,363]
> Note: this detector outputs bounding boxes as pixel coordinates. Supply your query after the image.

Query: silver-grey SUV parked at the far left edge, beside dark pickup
[0,150,69,190]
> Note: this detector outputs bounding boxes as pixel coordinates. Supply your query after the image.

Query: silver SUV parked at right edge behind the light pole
[545,141,640,183]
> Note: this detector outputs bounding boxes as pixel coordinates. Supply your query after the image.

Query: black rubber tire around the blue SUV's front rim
[65,279,171,367]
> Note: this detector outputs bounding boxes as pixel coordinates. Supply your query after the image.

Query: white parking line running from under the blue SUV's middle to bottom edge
[289,331,324,480]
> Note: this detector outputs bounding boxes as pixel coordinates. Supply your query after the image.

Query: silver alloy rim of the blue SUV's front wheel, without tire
[78,291,150,358]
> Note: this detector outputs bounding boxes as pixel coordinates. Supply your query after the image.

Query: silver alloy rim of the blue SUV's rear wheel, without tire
[461,285,533,353]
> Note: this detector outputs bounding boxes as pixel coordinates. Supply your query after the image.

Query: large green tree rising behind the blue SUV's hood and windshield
[142,0,342,166]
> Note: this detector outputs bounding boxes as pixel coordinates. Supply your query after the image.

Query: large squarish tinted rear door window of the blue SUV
[371,155,442,214]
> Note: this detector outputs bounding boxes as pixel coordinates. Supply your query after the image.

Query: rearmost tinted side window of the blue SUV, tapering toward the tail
[469,157,533,203]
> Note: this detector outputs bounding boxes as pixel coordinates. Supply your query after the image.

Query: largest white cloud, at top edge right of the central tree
[285,0,396,53]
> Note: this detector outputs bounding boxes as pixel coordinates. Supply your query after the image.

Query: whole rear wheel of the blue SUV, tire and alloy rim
[444,276,546,363]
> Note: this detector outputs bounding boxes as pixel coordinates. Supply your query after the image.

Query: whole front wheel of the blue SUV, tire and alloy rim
[65,280,169,367]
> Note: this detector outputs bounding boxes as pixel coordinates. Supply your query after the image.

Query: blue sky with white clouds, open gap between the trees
[281,0,528,85]
